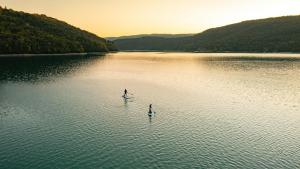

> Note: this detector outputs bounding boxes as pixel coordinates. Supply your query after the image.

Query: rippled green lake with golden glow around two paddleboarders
[0,52,300,169]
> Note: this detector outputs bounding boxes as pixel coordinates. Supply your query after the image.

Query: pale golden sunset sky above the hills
[0,0,300,37]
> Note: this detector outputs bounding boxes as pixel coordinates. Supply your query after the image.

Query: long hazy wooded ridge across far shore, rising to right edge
[114,15,300,52]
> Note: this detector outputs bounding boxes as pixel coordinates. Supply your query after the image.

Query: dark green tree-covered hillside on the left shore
[0,7,115,54]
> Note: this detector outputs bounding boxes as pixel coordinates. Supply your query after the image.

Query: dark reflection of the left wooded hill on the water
[0,54,105,82]
